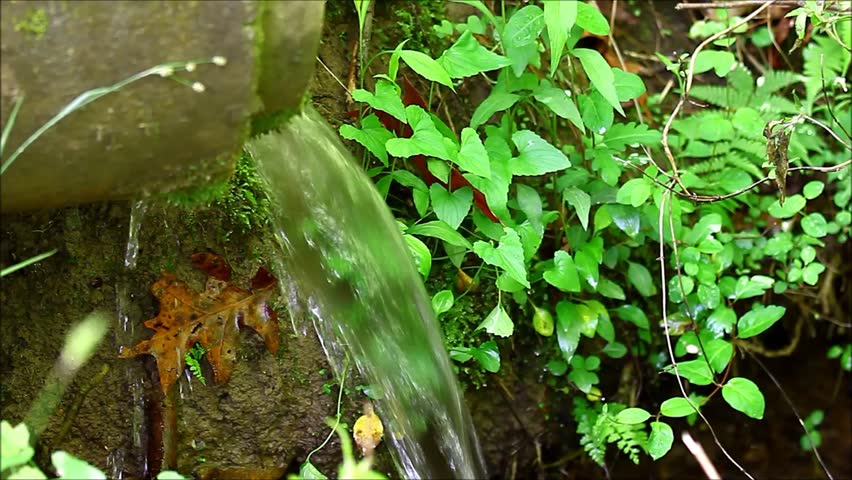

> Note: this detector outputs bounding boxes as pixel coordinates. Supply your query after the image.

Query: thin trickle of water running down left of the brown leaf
[107,200,149,479]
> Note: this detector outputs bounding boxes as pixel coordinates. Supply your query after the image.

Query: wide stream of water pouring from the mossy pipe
[249,109,484,478]
